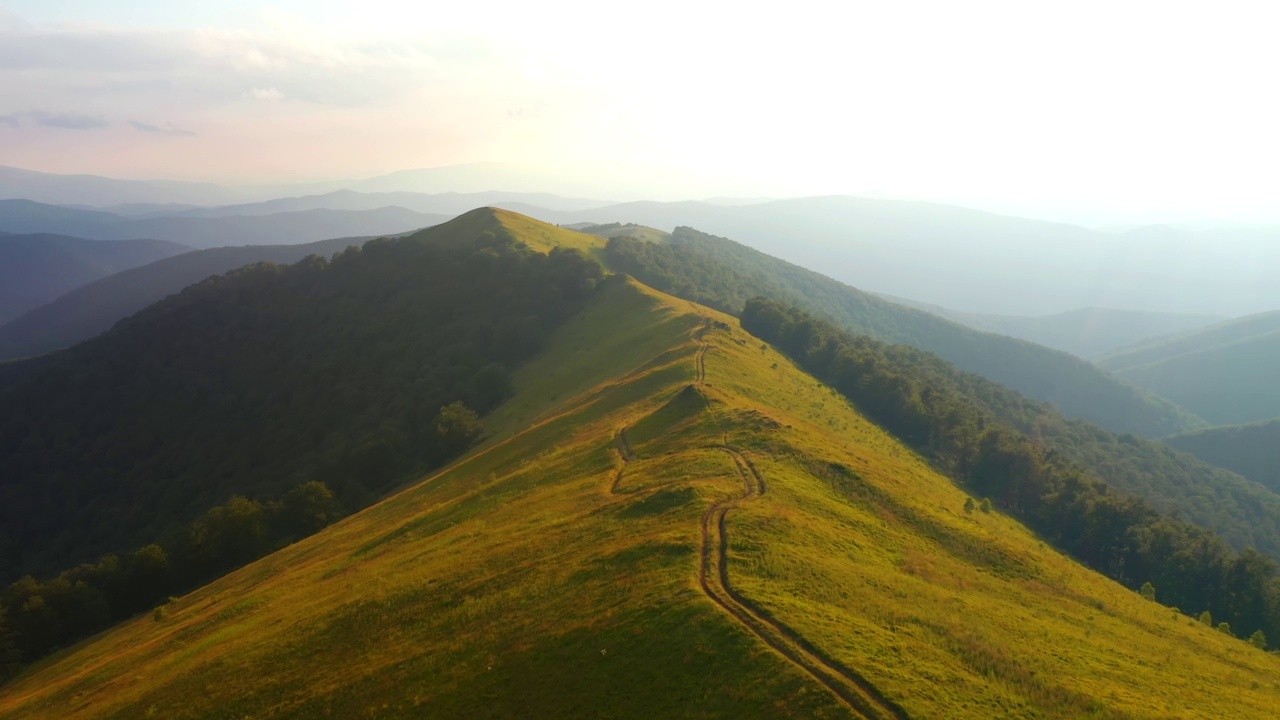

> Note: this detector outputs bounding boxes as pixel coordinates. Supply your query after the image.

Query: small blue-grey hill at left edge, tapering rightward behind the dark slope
[0,233,191,323]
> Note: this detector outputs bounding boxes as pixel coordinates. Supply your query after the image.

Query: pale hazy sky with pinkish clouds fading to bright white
[0,0,1280,224]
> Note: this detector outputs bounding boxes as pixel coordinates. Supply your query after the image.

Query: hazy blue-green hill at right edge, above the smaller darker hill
[1097,311,1280,425]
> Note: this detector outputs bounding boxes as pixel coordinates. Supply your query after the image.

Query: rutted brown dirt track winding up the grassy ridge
[609,316,910,720]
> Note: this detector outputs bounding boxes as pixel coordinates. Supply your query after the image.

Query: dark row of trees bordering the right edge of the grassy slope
[742,299,1280,642]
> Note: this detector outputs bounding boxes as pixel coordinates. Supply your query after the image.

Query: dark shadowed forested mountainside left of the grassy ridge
[0,206,602,582]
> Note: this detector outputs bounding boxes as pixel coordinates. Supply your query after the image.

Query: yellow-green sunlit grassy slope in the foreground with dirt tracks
[0,281,1280,719]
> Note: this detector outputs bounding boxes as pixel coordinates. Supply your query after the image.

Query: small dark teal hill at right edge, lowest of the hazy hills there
[1165,419,1280,493]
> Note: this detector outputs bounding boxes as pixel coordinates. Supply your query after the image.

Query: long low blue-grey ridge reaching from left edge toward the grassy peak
[0,200,448,249]
